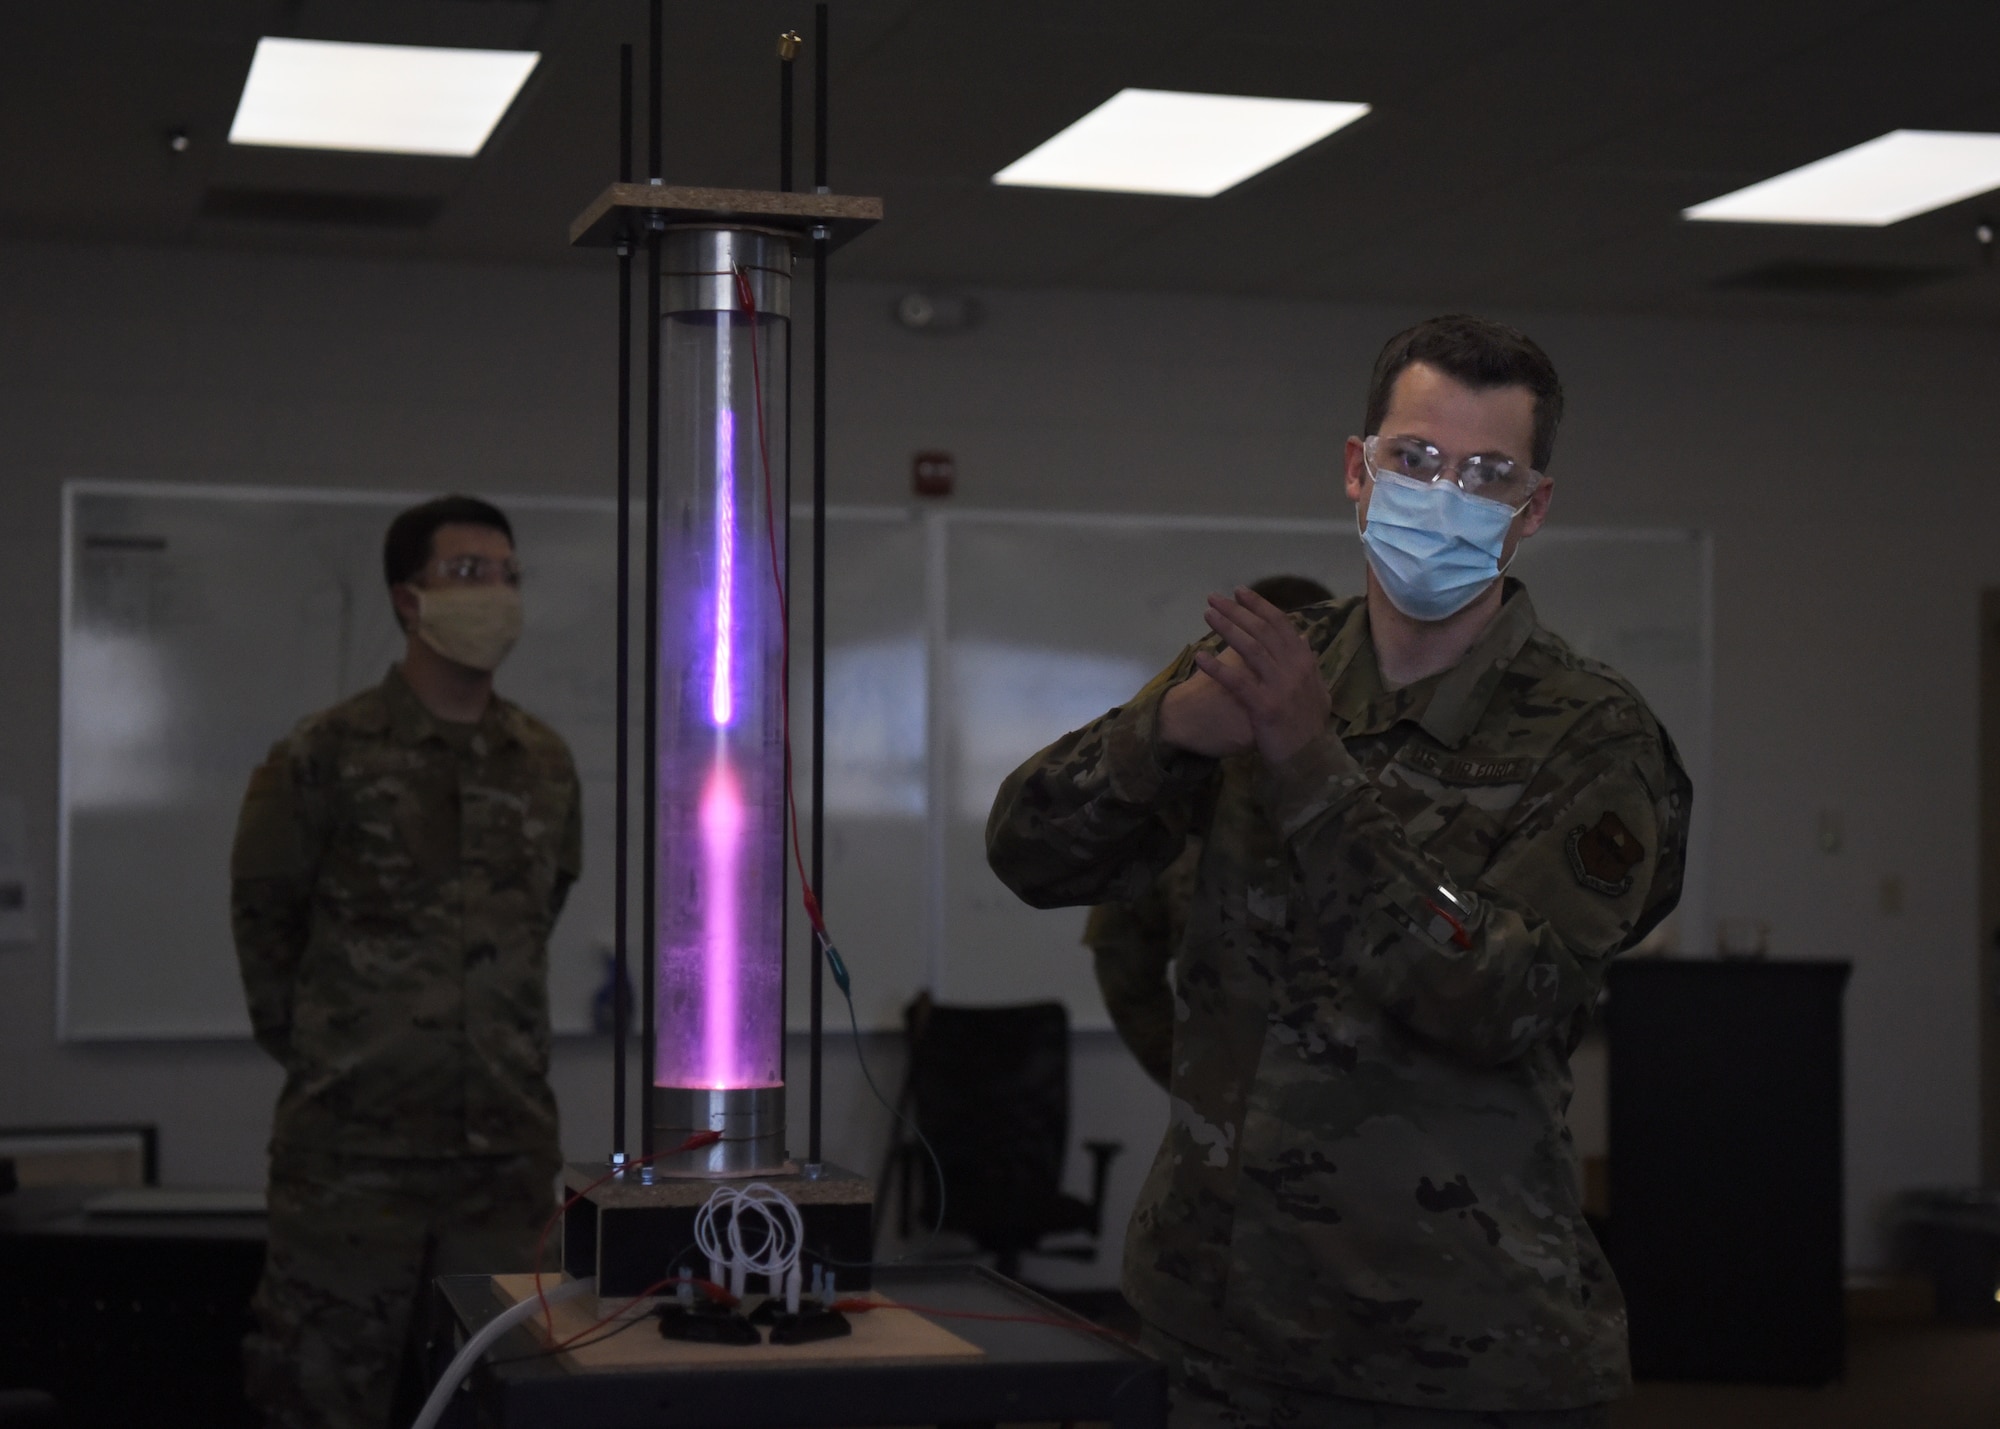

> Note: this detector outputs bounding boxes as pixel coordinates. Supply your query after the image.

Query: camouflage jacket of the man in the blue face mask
[986,580,1690,1411]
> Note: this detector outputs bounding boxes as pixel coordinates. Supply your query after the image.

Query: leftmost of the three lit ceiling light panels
[230,36,542,158]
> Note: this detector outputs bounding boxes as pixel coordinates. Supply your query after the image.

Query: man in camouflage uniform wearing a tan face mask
[230,496,582,1429]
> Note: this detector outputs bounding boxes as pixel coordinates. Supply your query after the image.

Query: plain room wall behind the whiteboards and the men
[0,244,2000,1283]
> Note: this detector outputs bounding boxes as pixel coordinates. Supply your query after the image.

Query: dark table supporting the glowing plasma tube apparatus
[438,1267,1166,1429]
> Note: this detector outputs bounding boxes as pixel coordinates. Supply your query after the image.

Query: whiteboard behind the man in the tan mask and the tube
[58,482,926,1041]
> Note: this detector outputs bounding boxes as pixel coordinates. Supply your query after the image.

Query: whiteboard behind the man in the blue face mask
[932,512,1710,1012]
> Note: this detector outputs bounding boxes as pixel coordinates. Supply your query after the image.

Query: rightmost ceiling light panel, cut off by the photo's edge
[1680,128,2000,228]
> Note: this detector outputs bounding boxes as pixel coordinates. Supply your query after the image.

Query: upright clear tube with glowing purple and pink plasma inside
[654,228,792,1104]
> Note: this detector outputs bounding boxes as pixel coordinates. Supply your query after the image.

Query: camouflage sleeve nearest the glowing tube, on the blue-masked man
[986,646,1218,909]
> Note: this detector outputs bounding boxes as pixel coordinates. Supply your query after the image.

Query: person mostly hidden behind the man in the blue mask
[1084,576,1334,1087]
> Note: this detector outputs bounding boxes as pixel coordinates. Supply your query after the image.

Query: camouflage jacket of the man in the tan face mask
[230,668,582,1157]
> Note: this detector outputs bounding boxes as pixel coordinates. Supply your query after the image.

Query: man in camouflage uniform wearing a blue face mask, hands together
[986,318,1690,1429]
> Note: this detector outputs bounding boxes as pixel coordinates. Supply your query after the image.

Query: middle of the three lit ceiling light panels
[994,90,1368,198]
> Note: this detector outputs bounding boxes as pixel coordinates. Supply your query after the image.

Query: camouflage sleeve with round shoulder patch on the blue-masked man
[1264,702,1686,1065]
